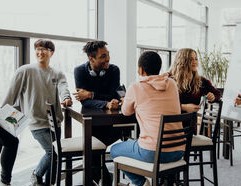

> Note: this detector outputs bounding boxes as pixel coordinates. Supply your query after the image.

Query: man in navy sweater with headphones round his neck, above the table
[74,41,120,109]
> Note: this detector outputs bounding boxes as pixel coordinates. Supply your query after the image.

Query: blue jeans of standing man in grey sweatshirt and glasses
[31,128,56,185]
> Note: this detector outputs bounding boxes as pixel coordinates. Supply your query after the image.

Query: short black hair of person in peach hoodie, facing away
[138,51,162,76]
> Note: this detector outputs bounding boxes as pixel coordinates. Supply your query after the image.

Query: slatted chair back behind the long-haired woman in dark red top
[199,99,223,144]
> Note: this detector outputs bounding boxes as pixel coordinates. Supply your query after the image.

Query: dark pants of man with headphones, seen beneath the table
[92,126,131,186]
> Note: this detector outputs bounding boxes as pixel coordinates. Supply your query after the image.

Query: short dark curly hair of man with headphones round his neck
[83,41,108,58]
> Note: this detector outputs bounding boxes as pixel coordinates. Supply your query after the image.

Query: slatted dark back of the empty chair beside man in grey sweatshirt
[46,102,62,154]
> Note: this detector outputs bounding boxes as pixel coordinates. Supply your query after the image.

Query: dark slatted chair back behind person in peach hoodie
[154,112,197,174]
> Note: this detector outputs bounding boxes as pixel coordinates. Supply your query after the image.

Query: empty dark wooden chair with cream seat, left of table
[46,103,106,186]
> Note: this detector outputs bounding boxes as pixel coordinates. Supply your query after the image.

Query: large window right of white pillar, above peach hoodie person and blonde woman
[137,0,208,67]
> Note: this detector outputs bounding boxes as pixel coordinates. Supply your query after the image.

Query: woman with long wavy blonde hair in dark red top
[169,48,221,134]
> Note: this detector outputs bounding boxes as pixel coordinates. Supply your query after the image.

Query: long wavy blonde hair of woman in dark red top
[170,48,202,94]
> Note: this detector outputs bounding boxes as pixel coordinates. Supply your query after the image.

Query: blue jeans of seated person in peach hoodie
[110,140,184,186]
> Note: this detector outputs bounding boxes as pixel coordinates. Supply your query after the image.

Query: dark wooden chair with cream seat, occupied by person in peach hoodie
[113,113,197,186]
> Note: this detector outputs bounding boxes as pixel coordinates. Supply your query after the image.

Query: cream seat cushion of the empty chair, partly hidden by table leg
[53,136,106,153]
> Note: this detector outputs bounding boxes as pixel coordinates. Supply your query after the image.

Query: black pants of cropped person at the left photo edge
[0,127,19,183]
